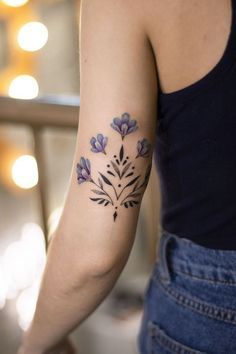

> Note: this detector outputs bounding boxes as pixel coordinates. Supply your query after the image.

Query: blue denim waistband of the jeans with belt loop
[157,228,236,284]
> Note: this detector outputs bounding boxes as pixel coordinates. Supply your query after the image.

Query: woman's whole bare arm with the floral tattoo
[19,0,157,354]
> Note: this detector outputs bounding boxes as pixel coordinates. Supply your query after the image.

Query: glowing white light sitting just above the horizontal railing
[8,75,39,100]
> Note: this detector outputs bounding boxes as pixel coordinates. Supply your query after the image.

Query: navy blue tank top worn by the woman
[154,0,236,250]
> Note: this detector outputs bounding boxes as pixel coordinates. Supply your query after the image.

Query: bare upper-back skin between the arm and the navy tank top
[140,0,232,93]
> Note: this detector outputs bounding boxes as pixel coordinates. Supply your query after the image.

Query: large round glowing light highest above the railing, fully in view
[17,22,48,52]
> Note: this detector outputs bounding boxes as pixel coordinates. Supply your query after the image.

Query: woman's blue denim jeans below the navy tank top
[137,229,236,354]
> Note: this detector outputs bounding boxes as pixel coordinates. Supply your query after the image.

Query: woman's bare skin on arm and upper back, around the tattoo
[18,0,230,354]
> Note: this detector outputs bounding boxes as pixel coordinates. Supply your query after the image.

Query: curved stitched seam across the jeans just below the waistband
[153,276,236,324]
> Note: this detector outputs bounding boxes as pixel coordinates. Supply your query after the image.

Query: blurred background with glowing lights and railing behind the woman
[0,0,160,354]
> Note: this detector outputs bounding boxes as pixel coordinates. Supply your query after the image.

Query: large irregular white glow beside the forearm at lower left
[0,223,46,330]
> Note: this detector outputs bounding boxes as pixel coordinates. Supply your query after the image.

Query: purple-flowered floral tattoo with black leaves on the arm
[76,112,151,221]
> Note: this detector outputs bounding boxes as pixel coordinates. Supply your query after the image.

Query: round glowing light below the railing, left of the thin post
[12,155,38,189]
